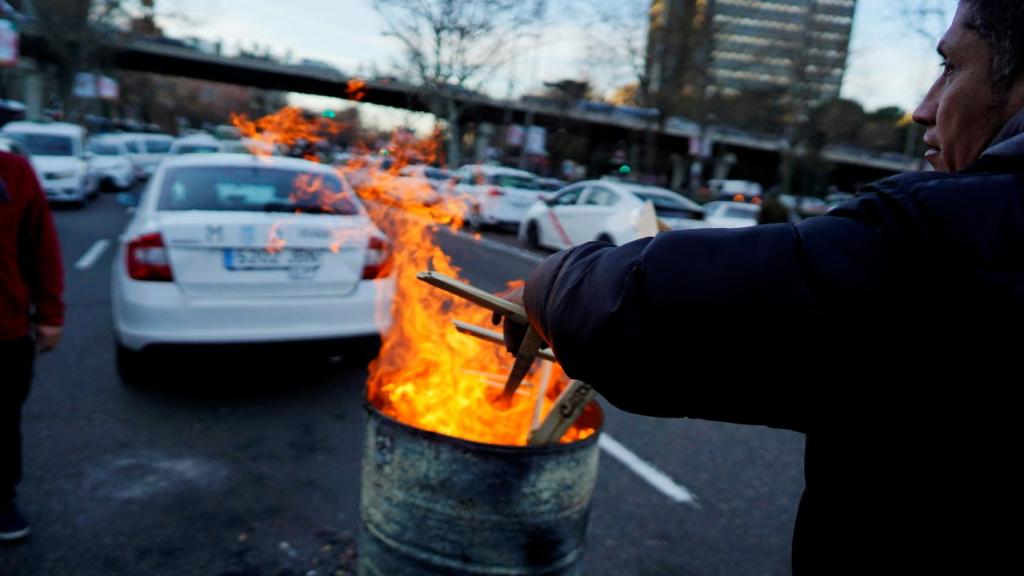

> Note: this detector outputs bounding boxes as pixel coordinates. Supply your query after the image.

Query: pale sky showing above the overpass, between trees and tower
[158,0,956,125]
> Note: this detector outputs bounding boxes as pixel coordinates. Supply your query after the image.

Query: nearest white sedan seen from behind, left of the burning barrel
[111,154,394,382]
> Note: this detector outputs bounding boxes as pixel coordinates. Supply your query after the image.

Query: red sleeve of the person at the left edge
[18,160,65,326]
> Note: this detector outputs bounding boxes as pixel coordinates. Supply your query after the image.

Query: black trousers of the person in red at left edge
[0,336,36,507]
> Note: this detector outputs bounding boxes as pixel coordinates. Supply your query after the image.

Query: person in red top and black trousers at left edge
[0,147,63,540]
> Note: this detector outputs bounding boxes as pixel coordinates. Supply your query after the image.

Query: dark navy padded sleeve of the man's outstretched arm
[524,189,927,429]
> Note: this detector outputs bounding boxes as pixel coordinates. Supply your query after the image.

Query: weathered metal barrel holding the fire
[359,403,603,576]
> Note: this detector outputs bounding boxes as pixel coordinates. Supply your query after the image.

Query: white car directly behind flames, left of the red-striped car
[454,164,546,228]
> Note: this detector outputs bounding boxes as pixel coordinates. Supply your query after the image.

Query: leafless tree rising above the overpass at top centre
[374,0,547,166]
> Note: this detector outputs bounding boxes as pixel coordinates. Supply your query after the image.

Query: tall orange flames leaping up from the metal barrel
[229,109,594,446]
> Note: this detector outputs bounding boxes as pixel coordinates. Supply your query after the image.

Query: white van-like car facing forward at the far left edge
[0,122,98,206]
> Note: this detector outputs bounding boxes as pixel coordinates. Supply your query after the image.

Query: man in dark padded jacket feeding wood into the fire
[506,0,1024,575]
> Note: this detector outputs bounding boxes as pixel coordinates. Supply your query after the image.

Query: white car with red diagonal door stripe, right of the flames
[519,180,705,250]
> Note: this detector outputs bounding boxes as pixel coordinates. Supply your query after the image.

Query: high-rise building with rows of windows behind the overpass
[647,0,856,110]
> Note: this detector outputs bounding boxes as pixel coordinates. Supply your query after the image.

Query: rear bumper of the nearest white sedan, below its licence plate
[113,277,394,351]
